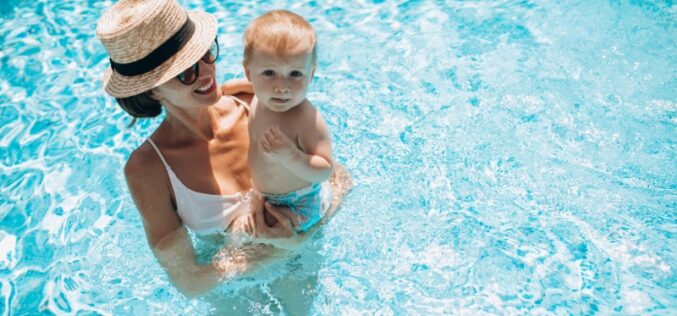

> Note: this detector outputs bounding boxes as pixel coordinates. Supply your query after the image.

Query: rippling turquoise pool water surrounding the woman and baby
[0,0,677,315]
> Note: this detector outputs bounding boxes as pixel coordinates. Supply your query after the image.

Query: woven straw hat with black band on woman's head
[96,0,216,98]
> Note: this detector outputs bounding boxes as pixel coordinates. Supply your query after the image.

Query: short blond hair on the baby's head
[243,10,317,65]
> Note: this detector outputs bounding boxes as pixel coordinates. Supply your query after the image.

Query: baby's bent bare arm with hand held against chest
[260,101,333,183]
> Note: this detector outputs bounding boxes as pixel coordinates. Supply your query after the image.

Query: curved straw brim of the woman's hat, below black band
[103,12,217,98]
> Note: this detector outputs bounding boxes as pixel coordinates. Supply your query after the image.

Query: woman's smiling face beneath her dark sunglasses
[152,59,221,109]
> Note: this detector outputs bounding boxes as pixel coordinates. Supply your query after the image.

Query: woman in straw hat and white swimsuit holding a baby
[97,0,350,296]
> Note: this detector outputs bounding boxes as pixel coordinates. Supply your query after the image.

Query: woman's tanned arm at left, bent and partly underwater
[125,145,282,297]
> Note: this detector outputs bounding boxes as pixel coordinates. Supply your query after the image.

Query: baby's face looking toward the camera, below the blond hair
[244,51,315,112]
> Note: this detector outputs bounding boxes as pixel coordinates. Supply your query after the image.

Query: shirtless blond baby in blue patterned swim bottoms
[243,10,332,232]
